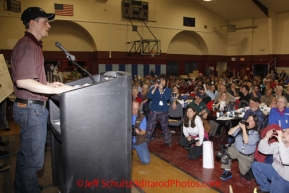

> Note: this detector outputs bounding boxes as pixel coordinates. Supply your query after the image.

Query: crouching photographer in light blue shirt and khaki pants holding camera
[217,115,260,183]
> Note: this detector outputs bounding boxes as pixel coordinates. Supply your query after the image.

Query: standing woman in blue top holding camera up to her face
[146,75,172,147]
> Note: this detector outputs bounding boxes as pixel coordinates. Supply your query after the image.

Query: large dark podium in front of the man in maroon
[49,72,132,193]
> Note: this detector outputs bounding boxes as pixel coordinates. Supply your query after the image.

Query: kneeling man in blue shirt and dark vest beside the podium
[131,101,150,164]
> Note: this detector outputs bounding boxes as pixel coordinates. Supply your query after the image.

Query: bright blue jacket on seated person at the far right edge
[268,108,289,129]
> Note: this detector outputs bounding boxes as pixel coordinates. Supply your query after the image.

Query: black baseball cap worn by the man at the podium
[21,7,55,25]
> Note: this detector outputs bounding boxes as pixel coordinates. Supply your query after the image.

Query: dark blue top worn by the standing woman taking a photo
[147,87,172,112]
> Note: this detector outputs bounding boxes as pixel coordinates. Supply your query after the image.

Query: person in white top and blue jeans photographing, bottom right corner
[252,129,289,193]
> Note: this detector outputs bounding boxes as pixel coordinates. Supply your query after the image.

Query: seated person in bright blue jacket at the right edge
[268,96,289,129]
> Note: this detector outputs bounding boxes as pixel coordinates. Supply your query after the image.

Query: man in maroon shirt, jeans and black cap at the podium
[11,7,73,193]
